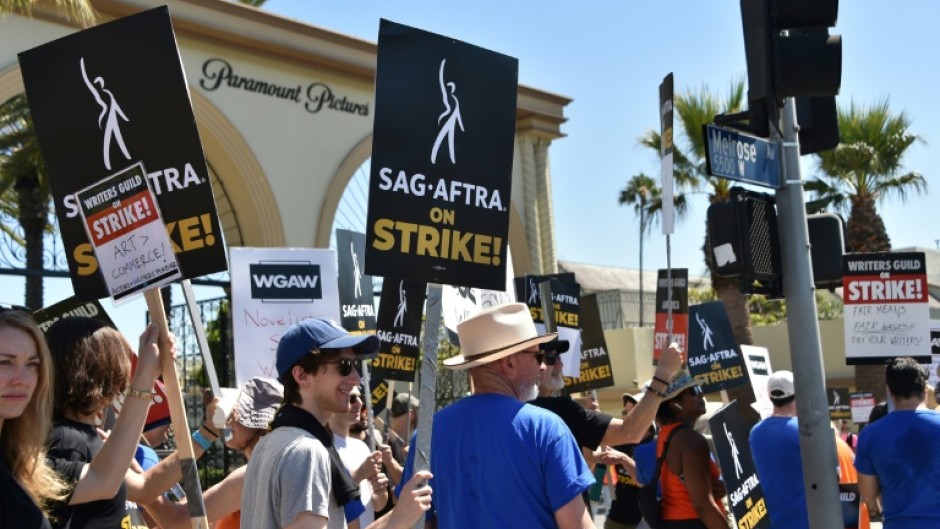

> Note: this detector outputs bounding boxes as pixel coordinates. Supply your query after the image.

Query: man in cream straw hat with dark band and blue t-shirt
[431,303,594,529]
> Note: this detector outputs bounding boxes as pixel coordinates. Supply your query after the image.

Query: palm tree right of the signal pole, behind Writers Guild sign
[806,97,927,400]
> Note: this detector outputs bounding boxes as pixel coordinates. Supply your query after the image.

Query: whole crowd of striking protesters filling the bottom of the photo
[0,303,940,529]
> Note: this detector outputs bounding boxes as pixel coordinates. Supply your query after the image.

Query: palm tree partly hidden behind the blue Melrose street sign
[640,79,754,344]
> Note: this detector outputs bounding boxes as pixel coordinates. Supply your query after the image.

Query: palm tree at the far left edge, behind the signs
[0,94,52,308]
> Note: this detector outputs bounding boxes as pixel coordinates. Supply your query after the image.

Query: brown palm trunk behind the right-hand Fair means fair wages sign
[846,195,891,402]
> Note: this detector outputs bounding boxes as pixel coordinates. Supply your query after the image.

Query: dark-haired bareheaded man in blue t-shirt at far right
[855,358,940,529]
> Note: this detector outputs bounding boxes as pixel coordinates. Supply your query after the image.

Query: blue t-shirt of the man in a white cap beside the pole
[750,417,809,529]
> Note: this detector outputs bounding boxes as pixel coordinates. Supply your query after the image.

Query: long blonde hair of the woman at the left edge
[0,310,66,514]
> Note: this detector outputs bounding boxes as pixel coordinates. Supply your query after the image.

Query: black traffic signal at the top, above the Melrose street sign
[741,0,842,139]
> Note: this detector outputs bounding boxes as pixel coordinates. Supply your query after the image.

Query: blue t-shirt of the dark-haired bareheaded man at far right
[855,410,940,529]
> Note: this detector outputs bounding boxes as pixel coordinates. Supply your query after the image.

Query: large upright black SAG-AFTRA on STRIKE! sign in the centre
[366,20,518,290]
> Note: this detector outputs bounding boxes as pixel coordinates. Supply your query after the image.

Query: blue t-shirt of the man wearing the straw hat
[422,394,594,529]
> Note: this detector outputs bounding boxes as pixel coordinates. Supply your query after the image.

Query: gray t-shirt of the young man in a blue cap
[241,426,346,529]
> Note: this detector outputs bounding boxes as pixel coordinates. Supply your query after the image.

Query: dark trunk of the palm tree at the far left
[14,173,49,310]
